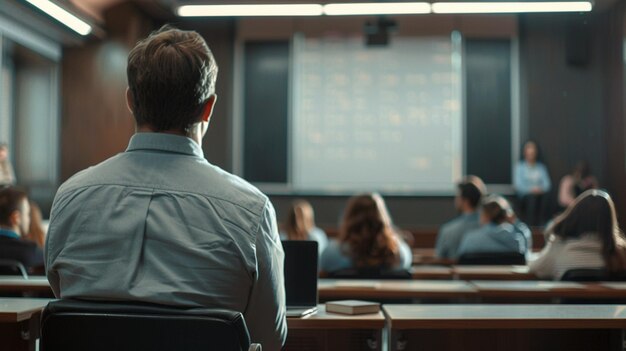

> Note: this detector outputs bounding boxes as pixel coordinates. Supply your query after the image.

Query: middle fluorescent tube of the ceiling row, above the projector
[324,2,430,16]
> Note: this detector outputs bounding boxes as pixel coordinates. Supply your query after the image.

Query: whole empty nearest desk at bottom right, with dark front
[383,305,626,351]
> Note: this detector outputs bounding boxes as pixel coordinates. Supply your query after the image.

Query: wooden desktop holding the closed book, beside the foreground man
[287,304,385,330]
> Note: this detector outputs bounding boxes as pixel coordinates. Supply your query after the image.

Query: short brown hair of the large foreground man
[126,25,217,132]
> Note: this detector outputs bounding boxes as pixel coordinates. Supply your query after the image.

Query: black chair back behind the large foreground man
[40,300,261,351]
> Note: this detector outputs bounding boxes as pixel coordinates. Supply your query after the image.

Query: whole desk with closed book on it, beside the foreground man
[285,305,385,351]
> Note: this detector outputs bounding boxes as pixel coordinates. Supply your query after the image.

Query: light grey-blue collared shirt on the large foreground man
[45,133,287,350]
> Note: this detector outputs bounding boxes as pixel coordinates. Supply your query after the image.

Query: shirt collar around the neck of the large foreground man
[126,133,204,158]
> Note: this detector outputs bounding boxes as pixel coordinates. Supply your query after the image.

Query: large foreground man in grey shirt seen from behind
[45,26,287,350]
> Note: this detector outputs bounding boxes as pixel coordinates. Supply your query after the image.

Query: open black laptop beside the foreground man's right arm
[282,240,318,317]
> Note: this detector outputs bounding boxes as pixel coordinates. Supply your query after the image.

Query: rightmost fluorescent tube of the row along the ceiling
[432,1,593,13]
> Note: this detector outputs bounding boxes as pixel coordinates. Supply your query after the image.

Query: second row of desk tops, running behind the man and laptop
[0,277,626,301]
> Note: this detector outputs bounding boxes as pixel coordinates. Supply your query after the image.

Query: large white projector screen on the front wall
[291,36,463,193]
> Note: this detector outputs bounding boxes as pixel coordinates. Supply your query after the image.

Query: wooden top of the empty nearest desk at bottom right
[383,305,626,329]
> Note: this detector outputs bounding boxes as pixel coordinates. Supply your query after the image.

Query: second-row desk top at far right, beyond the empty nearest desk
[470,281,626,299]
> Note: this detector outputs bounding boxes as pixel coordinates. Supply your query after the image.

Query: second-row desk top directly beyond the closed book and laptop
[318,279,477,299]
